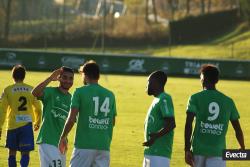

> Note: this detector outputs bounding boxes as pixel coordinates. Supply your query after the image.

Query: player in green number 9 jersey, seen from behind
[185,64,245,167]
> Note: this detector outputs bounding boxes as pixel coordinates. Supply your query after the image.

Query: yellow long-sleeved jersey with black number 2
[0,82,41,130]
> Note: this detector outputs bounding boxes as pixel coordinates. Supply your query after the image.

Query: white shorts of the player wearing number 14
[70,148,110,167]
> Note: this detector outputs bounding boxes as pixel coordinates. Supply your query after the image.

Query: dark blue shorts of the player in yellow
[5,123,34,152]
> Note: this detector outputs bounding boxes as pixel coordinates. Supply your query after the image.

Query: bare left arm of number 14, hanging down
[58,108,79,154]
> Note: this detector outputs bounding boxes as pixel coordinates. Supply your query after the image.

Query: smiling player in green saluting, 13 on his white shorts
[32,67,74,167]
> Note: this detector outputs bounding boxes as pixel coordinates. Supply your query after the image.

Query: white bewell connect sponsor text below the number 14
[89,116,110,130]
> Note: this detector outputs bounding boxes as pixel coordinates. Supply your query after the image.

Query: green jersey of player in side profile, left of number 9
[144,92,174,158]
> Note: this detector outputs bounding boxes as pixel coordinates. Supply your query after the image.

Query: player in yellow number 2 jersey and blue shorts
[0,65,41,167]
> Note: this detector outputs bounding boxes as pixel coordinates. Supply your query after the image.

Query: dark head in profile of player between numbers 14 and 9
[147,71,167,95]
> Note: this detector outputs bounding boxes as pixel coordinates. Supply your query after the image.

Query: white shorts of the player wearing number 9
[194,155,226,167]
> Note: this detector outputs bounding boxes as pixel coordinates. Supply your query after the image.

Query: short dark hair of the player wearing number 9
[200,64,220,84]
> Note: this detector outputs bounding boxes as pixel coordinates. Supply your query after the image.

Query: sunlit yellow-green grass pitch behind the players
[0,71,250,167]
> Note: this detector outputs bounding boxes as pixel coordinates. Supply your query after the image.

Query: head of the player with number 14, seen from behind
[79,60,100,85]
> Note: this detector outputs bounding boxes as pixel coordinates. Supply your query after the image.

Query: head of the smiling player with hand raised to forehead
[59,66,74,90]
